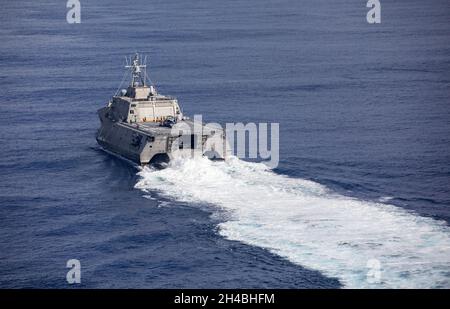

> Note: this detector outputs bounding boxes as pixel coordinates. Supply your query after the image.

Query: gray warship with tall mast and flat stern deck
[96,54,229,166]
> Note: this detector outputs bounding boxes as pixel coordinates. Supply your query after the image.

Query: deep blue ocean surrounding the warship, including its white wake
[0,0,450,288]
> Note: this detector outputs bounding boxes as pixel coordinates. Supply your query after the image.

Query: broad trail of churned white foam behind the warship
[136,158,450,288]
